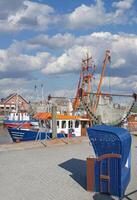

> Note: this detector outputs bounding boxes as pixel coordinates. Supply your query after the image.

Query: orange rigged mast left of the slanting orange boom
[73,54,96,112]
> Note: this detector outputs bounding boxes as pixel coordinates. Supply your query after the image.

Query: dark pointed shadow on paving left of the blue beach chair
[59,158,86,190]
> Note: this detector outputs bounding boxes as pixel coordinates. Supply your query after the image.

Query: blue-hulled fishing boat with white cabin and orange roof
[8,112,89,142]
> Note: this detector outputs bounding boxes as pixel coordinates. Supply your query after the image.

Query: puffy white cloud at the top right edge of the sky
[66,0,135,29]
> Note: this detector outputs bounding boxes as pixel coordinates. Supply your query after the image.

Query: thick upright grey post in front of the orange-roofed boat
[52,105,57,138]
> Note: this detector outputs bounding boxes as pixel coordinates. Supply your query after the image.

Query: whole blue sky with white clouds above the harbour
[0,0,137,101]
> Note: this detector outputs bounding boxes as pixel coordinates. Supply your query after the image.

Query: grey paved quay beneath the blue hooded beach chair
[0,136,137,200]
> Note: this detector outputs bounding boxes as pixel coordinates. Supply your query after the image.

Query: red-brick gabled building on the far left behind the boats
[0,93,29,113]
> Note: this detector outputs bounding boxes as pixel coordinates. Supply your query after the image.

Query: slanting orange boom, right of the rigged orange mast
[93,50,110,113]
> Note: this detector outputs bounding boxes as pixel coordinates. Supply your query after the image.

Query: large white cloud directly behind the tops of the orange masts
[42,32,137,76]
